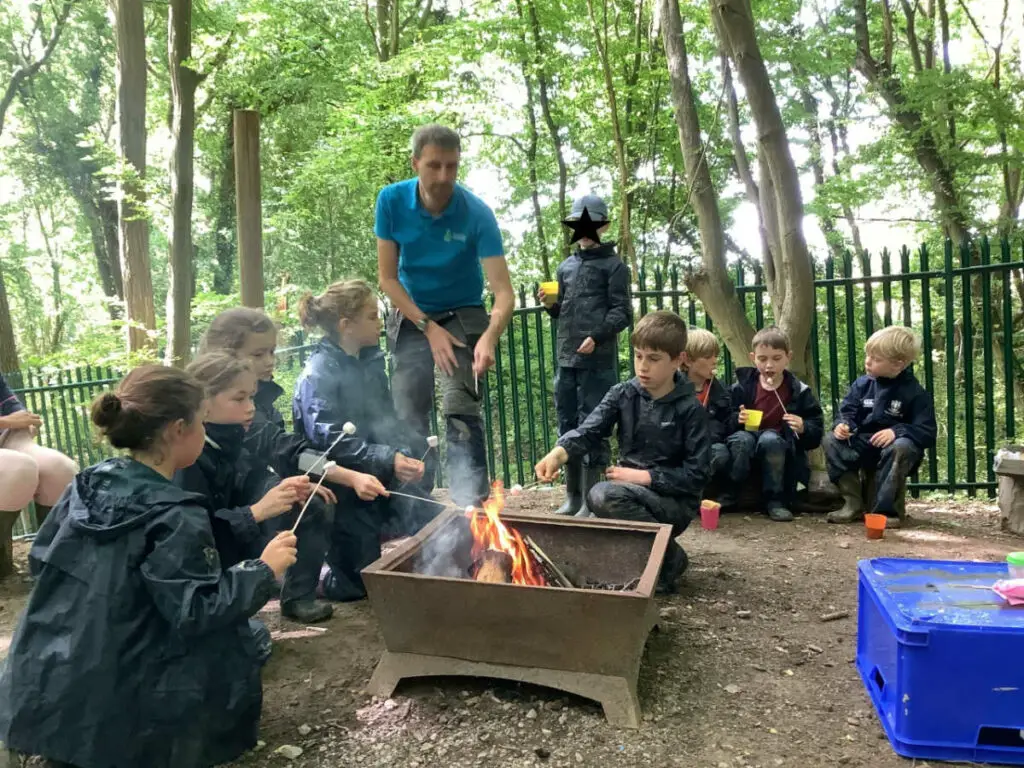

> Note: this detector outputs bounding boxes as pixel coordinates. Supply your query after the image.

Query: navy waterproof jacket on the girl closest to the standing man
[292,338,417,484]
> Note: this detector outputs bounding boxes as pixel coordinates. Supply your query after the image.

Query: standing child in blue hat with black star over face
[538,195,632,517]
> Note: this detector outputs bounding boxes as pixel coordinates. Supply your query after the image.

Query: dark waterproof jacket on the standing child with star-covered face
[548,242,633,370]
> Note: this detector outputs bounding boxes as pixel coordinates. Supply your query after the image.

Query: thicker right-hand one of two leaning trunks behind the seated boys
[711,0,815,377]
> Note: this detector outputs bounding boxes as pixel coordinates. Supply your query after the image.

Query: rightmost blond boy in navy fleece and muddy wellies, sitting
[824,326,937,527]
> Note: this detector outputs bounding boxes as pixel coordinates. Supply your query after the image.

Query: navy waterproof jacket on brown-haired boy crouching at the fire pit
[558,373,711,503]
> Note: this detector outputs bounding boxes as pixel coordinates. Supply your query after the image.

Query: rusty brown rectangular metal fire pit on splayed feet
[362,510,672,728]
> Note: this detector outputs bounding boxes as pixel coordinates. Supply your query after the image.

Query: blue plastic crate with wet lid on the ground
[857,558,1024,765]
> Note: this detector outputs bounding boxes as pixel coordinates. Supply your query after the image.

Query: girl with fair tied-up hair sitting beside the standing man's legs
[292,280,439,600]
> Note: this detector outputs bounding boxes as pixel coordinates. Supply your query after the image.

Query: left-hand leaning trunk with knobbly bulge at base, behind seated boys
[662,0,754,360]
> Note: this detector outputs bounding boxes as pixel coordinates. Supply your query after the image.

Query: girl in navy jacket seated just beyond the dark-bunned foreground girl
[174,352,342,626]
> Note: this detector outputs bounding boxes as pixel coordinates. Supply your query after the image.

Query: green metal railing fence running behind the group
[6,240,1024,532]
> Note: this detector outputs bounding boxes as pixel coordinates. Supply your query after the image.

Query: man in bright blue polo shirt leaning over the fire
[374,125,514,506]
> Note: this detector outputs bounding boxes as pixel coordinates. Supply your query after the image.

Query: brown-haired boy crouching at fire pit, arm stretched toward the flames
[536,311,711,594]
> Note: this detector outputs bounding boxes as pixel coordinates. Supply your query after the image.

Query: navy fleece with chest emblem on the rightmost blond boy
[833,368,938,451]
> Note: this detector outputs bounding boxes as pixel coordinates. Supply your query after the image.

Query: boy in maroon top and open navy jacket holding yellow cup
[728,326,824,522]
